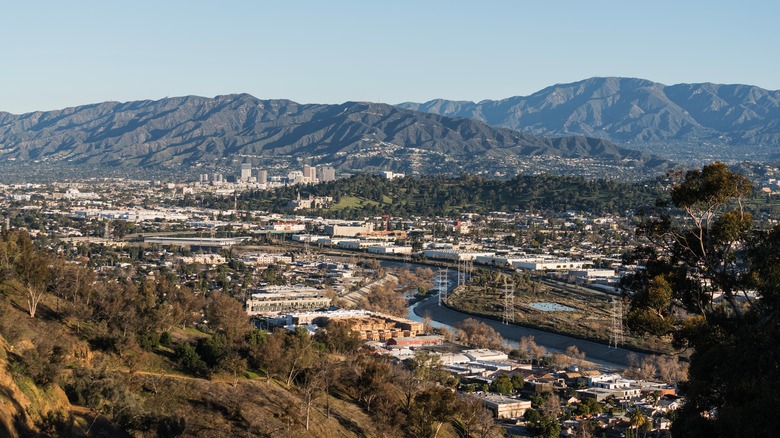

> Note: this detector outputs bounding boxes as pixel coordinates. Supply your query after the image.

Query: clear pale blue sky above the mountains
[0,0,780,114]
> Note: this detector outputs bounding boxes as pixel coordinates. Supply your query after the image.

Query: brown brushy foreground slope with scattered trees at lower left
[0,231,500,437]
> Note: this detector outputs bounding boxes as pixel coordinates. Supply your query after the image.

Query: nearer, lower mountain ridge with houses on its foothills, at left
[0,94,665,178]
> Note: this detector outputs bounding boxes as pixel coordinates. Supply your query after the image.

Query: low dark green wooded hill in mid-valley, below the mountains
[185,174,659,218]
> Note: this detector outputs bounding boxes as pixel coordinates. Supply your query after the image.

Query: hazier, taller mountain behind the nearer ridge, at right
[398,77,780,158]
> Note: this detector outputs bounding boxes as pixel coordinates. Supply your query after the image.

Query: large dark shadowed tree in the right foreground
[622,163,780,436]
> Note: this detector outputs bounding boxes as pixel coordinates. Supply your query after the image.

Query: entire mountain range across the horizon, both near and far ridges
[0,78,780,181]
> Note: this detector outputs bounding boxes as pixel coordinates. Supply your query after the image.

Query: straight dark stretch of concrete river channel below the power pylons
[414,296,644,370]
